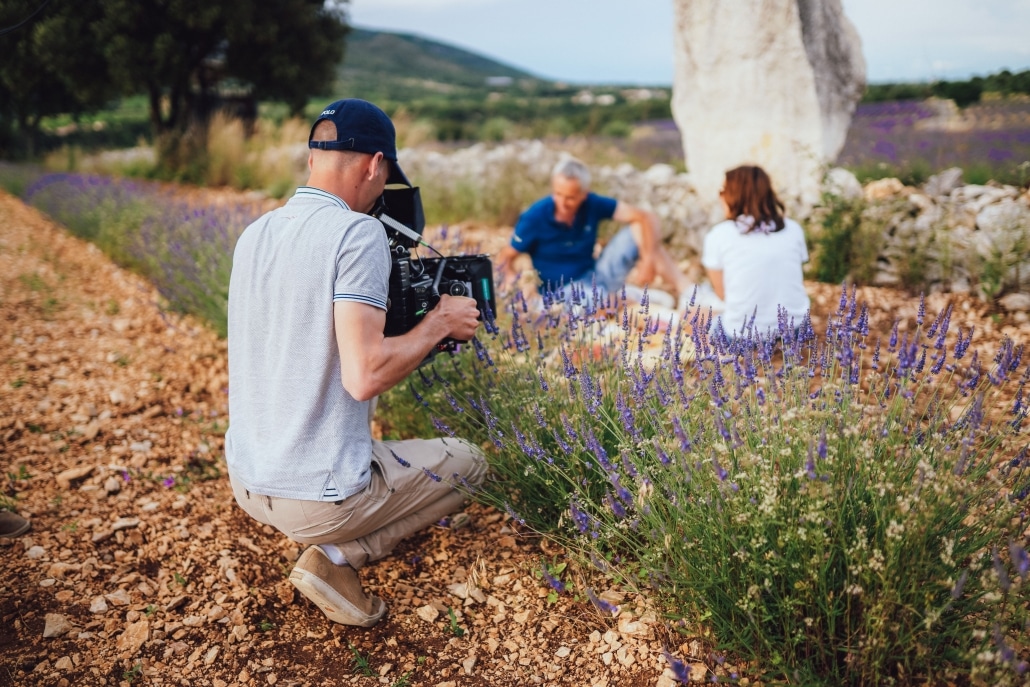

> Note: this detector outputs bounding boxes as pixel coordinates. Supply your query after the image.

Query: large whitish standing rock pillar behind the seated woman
[673,0,865,212]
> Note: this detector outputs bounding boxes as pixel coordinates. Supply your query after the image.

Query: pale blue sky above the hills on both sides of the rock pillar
[349,0,1030,85]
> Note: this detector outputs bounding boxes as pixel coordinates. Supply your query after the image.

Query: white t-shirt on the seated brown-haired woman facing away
[701,219,809,336]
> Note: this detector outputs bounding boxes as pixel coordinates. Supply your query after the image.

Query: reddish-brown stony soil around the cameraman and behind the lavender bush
[0,193,1030,687]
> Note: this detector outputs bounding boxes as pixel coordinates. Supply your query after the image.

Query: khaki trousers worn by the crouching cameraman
[229,439,486,569]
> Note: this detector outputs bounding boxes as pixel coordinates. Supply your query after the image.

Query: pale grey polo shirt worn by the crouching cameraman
[226,186,390,501]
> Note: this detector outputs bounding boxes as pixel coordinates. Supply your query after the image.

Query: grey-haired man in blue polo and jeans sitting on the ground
[496,158,693,303]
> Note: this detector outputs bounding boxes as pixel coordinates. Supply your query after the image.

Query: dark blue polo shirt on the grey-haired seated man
[511,193,618,286]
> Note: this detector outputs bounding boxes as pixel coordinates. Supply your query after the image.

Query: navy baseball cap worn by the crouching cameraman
[308,98,411,186]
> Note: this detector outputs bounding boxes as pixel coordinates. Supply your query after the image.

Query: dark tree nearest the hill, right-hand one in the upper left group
[94,0,347,136]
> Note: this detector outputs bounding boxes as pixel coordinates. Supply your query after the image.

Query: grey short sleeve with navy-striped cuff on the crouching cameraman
[333,217,390,310]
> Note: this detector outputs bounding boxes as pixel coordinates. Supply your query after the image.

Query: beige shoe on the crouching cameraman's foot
[289,546,386,627]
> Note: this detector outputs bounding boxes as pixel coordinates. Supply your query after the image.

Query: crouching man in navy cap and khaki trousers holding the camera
[226,99,486,627]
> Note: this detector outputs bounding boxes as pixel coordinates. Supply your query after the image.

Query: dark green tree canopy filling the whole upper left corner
[0,0,348,156]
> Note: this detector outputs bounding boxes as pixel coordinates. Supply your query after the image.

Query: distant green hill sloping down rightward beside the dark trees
[338,28,550,100]
